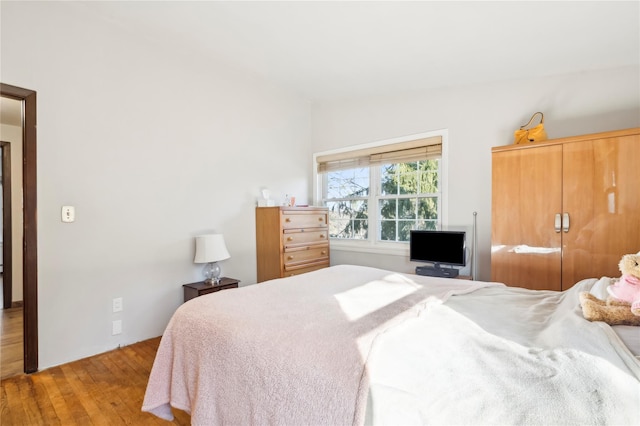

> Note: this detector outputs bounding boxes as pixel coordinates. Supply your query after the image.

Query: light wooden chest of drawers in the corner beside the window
[256,207,330,282]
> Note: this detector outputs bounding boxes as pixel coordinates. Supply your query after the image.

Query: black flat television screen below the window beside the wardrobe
[409,231,466,266]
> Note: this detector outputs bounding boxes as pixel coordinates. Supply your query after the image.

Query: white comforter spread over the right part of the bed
[367,280,640,425]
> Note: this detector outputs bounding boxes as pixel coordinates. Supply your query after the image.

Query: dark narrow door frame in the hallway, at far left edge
[0,141,13,309]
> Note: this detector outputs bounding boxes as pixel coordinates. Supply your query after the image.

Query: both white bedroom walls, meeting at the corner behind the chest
[0,2,640,368]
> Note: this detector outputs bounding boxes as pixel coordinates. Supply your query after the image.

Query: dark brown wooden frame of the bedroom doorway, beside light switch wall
[0,83,38,373]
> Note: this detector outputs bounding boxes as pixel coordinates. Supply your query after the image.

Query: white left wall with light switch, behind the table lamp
[0,2,311,369]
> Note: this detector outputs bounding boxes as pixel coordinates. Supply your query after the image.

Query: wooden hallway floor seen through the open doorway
[0,307,24,379]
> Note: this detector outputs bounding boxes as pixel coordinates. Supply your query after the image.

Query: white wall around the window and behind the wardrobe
[312,66,640,280]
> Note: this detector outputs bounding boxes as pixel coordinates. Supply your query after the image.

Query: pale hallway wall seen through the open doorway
[0,124,24,302]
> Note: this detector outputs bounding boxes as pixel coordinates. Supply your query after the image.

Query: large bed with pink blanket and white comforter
[142,265,640,425]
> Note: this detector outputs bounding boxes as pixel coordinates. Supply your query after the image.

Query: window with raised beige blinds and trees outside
[315,134,444,250]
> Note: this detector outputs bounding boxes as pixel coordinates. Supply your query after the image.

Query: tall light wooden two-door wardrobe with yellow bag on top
[491,128,640,290]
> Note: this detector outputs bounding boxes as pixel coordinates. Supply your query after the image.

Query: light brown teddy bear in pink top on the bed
[579,252,640,326]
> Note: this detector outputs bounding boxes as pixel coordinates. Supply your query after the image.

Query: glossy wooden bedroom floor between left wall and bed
[0,337,191,426]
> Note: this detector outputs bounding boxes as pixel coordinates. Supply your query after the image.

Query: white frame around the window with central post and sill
[313,129,449,256]
